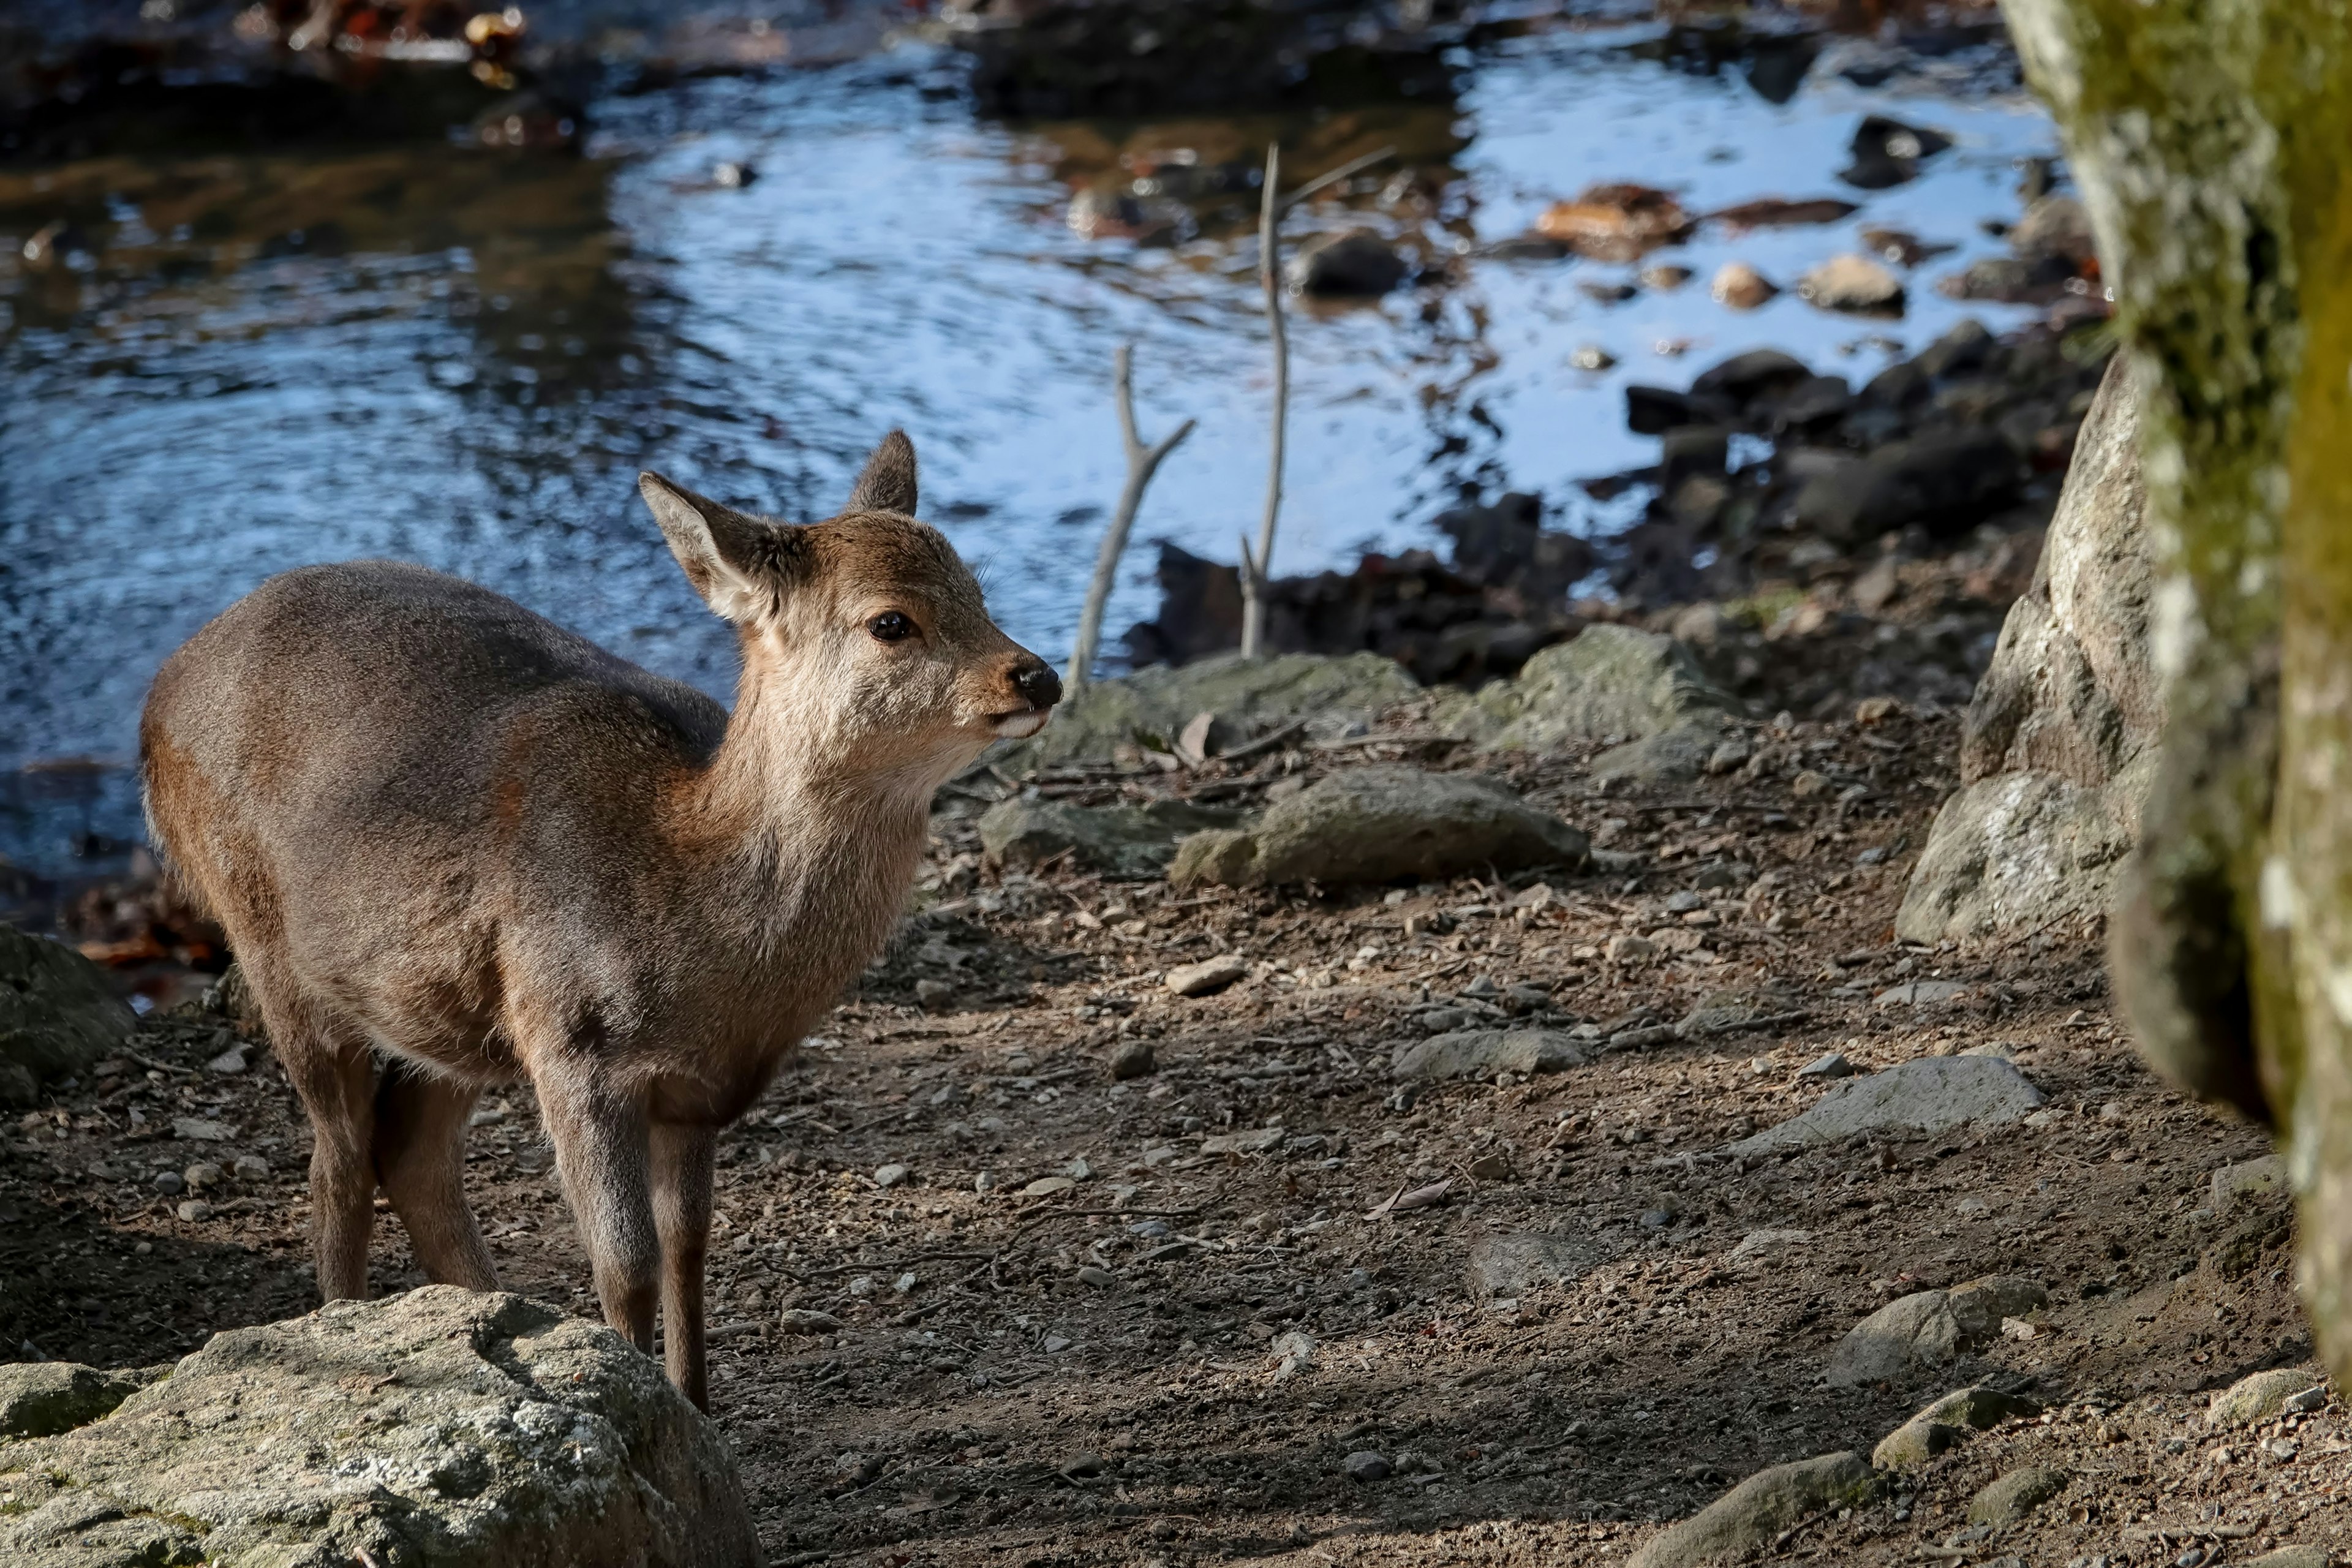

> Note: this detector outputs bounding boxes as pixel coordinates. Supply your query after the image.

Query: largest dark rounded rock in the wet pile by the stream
[1795,428,2022,545]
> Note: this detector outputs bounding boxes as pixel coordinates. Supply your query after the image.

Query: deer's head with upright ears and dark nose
[638,430,1061,785]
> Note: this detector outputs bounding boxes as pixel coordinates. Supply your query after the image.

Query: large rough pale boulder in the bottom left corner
[0,1286,760,1568]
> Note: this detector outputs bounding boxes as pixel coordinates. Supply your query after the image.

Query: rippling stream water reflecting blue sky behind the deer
[0,18,2056,870]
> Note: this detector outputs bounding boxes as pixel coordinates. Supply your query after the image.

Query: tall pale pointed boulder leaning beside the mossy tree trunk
[1896,355,2164,943]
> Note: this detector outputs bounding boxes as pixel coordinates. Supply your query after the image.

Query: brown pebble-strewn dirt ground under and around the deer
[0,682,2352,1568]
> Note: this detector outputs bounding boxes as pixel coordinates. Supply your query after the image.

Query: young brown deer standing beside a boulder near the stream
[139,430,1061,1403]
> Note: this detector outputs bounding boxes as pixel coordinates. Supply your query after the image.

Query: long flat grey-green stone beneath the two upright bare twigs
[986,654,1420,774]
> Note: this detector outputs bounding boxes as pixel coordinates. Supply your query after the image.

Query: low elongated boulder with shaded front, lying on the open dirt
[1169,766,1590,886]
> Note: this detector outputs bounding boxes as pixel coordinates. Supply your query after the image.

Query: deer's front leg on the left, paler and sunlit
[537,1069,661,1354]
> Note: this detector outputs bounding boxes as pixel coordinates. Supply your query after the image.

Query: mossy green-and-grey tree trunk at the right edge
[2004,0,2352,1382]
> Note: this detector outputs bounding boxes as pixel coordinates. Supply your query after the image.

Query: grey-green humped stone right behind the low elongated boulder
[1433,623,1738,752]
